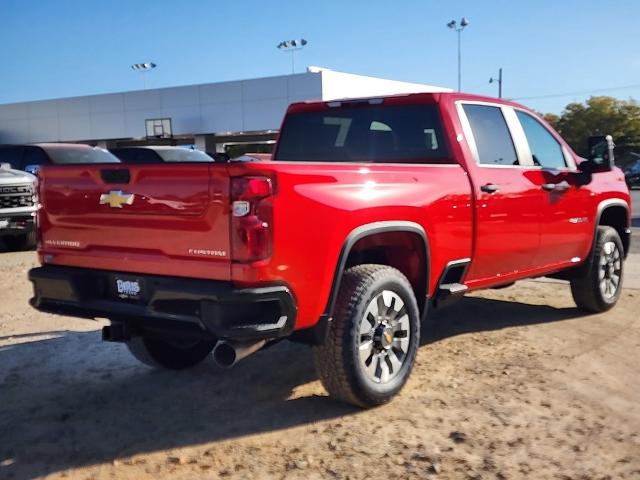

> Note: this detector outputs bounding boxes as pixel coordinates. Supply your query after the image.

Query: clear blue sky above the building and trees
[0,0,640,112]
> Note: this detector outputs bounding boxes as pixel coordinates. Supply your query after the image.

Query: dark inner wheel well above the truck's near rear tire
[345,231,429,312]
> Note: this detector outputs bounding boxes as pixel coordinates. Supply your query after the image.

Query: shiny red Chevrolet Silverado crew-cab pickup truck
[29,93,630,407]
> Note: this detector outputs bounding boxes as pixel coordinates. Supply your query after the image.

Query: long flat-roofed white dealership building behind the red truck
[0,67,450,152]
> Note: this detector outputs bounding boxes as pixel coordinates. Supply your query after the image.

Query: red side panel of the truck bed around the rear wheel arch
[229,162,472,328]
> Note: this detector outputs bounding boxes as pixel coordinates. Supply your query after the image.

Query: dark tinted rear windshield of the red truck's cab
[275,103,450,163]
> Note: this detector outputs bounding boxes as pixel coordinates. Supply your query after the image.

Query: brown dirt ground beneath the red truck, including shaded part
[0,252,640,480]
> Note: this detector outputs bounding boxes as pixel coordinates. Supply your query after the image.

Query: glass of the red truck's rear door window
[464,104,519,165]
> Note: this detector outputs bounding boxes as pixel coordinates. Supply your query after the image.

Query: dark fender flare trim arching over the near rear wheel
[319,220,431,323]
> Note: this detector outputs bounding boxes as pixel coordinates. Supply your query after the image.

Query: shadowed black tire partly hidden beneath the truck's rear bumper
[126,335,215,370]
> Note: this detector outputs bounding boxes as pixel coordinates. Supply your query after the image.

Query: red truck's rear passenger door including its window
[457,102,540,284]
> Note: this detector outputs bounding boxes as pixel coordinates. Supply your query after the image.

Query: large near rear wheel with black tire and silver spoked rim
[314,264,420,408]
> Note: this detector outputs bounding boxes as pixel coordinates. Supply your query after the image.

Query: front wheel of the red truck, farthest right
[571,227,624,313]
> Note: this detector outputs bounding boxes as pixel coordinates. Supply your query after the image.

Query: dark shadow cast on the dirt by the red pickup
[0,298,580,478]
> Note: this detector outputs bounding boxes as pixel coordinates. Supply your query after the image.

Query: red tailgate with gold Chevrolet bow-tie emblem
[38,164,230,280]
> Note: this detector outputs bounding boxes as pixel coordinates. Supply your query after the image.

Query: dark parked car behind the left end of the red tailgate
[0,143,118,173]
